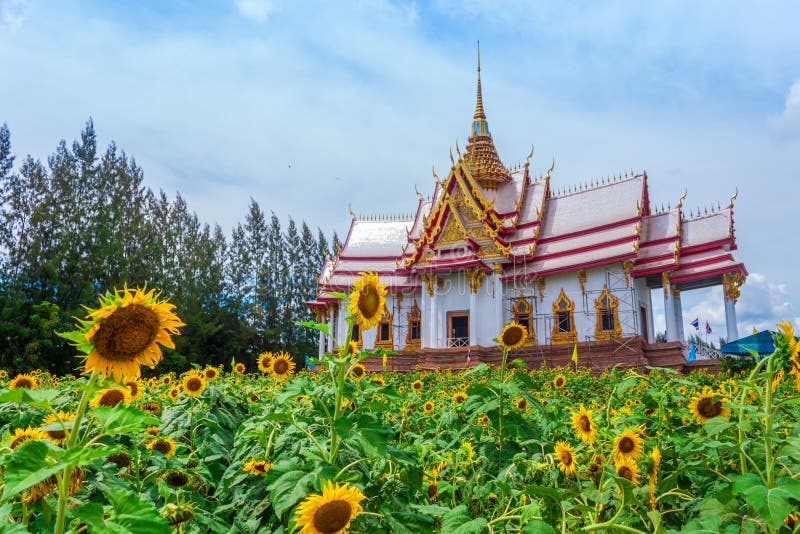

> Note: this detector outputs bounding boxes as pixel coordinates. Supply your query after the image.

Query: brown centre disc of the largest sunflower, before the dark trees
[93,304,159,361]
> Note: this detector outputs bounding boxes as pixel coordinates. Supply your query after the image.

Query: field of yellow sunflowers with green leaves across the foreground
[0,277,800,534]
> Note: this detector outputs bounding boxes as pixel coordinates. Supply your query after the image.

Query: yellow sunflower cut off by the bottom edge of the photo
[295,480,366,534]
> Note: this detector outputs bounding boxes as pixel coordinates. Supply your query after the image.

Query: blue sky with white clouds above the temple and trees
[0,0,800,342]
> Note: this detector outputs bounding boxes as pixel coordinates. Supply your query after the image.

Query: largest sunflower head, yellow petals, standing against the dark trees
[62,288,185,381]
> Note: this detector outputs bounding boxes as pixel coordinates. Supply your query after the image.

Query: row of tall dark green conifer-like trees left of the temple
[0,119,341,373]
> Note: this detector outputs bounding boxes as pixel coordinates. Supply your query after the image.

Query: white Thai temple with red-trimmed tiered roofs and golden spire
[307,53,747,370]
